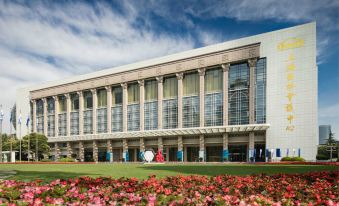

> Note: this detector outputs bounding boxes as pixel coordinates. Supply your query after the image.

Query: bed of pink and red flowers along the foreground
[0,171,339,205]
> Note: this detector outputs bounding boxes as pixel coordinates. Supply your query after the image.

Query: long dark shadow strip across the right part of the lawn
[139,165,338,176]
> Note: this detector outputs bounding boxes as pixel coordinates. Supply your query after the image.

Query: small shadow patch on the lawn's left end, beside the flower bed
[7,171,99,182]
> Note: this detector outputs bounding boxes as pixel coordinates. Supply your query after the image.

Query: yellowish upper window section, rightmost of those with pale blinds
[205,68,223,93]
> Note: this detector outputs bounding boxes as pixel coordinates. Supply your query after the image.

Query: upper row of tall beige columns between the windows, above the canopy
[32,59,256,136]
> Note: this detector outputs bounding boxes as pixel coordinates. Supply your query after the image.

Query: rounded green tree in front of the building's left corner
[21,133,51,160]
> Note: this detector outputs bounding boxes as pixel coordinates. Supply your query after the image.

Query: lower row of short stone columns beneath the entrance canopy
[54,132,255,162]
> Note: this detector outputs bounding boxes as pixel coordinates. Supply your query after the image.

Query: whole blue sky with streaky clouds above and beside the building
[0,0,339,137]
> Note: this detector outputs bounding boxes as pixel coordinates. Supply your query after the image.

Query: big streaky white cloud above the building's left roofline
[0,1,194,131]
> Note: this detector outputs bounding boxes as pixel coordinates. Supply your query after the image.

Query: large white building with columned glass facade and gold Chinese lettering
[16,23,318,162]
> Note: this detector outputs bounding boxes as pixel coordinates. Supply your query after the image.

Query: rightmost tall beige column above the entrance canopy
[248,59,257,124]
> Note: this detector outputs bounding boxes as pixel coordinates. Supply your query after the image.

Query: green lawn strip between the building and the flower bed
[0,163,339,181]
